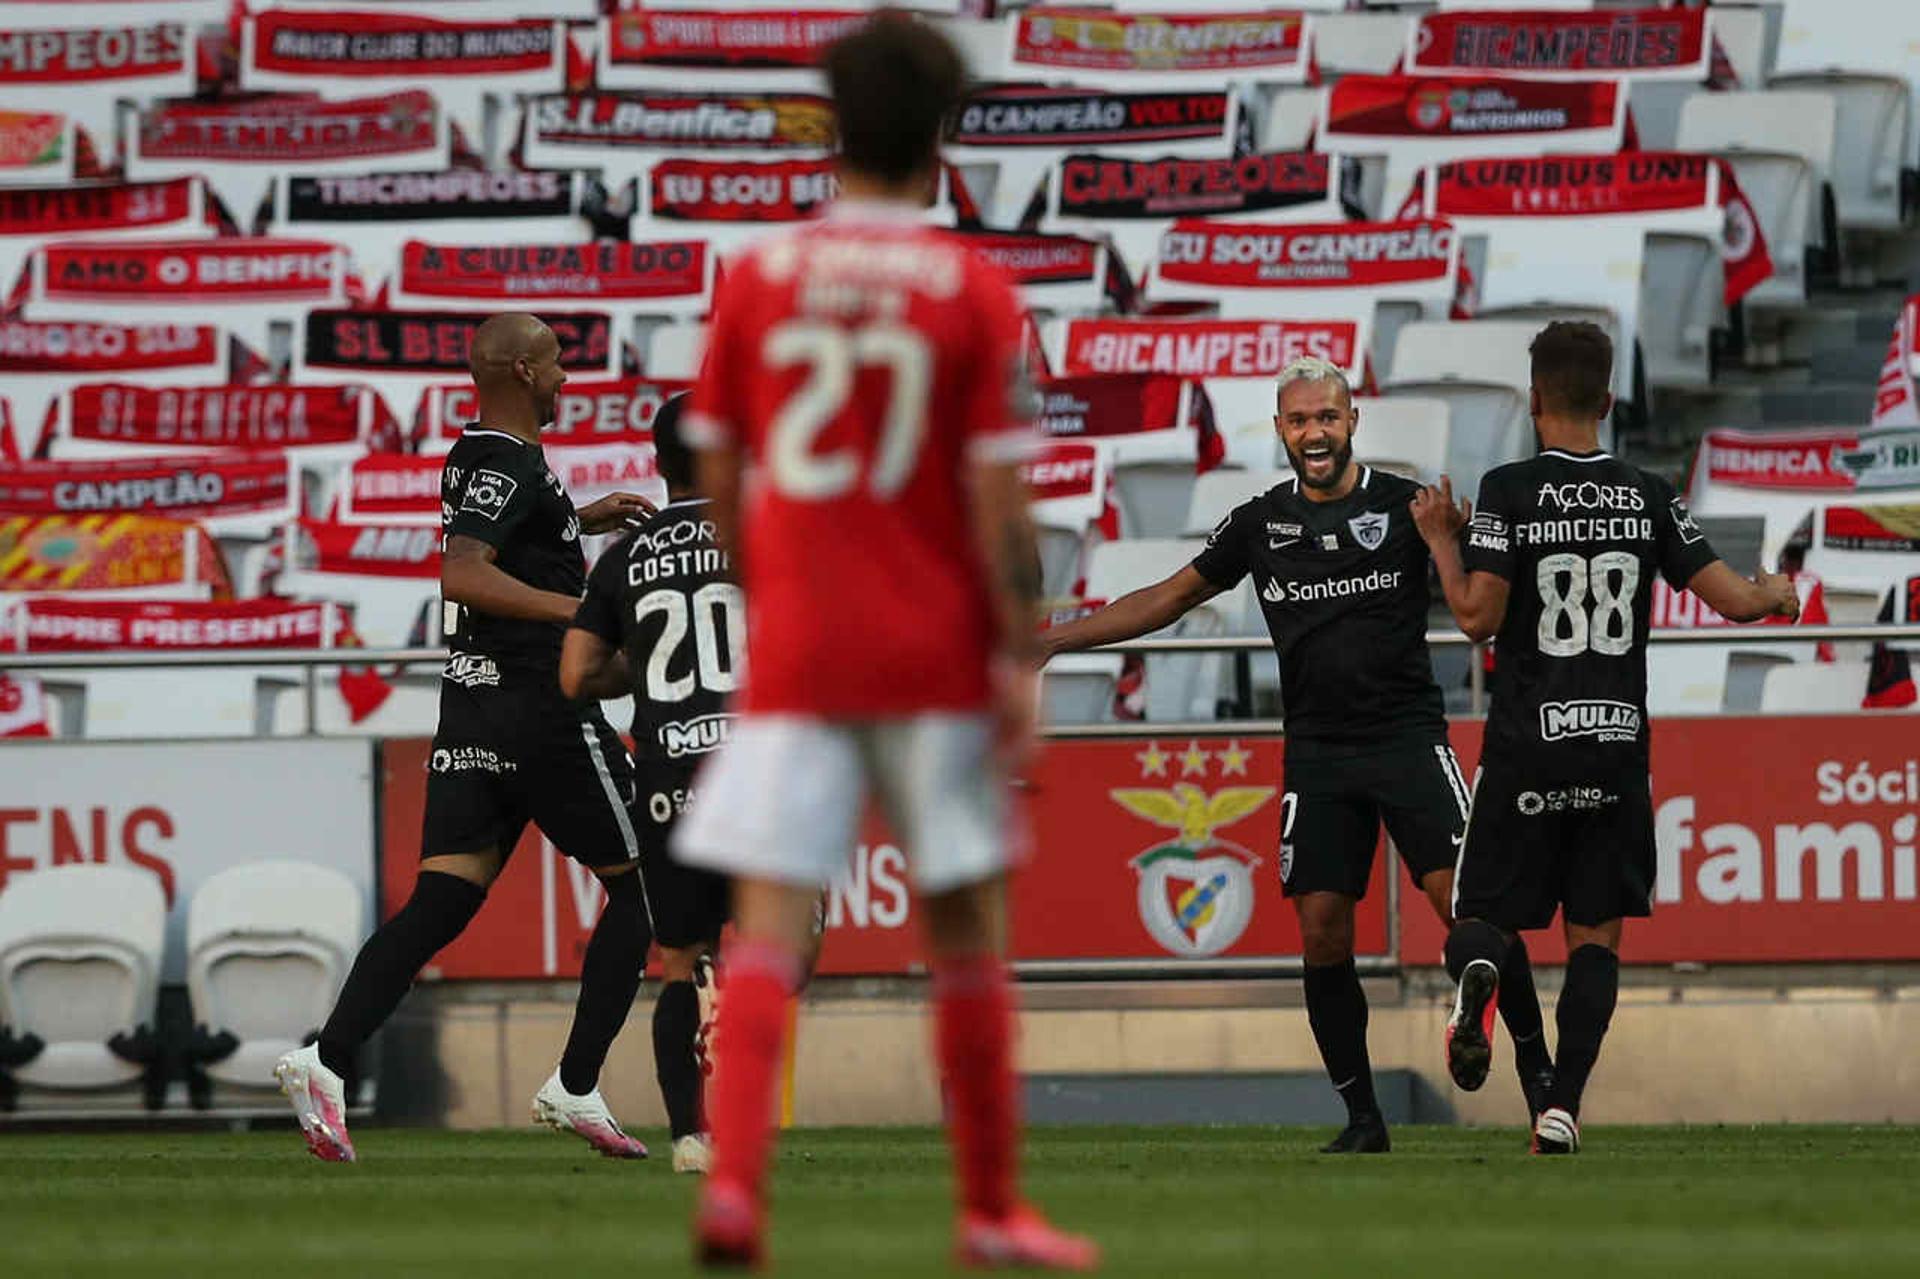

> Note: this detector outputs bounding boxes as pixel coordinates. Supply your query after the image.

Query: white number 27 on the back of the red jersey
[762,321,933,501]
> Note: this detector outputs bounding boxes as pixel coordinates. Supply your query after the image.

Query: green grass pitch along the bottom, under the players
[0,1125,1920,1279]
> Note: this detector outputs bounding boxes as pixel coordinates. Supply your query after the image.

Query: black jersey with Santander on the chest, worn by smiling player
[1194,467,1446,751]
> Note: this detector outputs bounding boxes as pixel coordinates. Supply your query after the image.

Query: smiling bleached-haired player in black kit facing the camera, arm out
[1043,359,1553,1154]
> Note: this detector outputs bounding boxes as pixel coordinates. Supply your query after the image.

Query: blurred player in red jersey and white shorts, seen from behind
[674,13,1098,1269]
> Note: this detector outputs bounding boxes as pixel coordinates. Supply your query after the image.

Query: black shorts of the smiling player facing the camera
[1281,739,1467,897]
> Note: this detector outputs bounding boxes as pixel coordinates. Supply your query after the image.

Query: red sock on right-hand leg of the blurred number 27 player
[933,954,1020,1219]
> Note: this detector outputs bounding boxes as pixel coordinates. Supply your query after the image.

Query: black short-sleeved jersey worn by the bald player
[440,426,588,672]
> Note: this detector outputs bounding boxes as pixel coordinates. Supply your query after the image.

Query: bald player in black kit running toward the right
[275,313,653,1162]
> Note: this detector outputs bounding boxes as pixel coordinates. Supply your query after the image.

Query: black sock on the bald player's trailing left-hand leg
[319,870,486,1079]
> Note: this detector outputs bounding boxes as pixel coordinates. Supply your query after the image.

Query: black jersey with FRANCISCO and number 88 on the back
[1465,449,1718,776]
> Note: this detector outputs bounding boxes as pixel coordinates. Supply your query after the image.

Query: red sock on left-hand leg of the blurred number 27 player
[707,941,801,1200]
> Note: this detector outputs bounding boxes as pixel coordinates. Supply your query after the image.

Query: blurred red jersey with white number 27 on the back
[687,202,1031,718]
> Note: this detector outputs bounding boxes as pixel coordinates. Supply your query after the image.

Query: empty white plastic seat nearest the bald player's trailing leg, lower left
[186,862,365,1089]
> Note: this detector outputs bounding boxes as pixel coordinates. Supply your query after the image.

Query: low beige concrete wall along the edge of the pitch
[393,970,1920,1127]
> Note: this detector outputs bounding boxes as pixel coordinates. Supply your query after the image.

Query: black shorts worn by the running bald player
[420,680,639,866]
